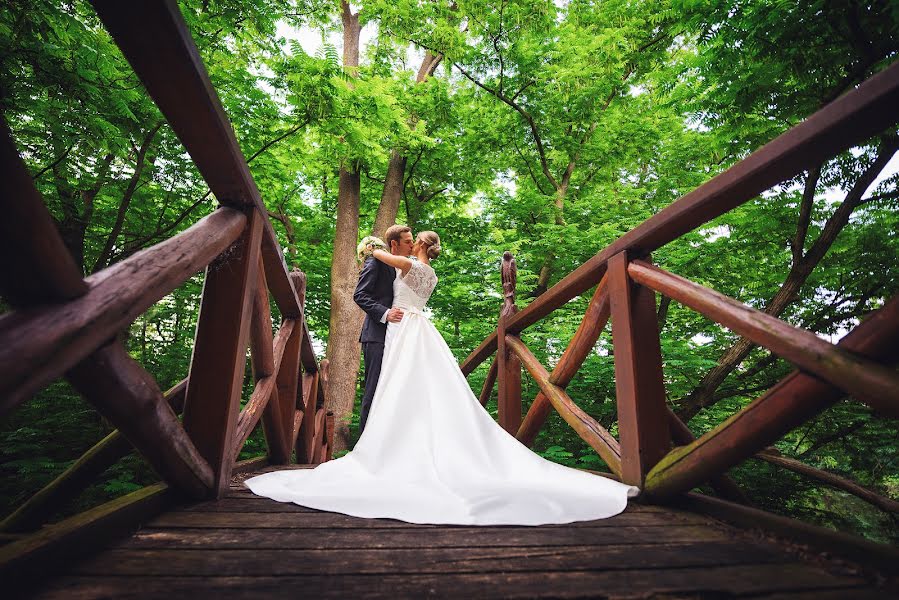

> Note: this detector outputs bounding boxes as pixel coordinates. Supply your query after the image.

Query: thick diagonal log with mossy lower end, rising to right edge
[645,296,899,497]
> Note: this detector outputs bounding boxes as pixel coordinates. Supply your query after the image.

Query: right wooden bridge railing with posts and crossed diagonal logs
[460,58,899,510]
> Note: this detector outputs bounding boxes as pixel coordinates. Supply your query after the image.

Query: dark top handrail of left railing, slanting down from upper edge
[91,0,302,319]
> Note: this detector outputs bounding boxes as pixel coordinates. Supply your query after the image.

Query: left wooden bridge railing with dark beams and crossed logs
[0,0,334,531]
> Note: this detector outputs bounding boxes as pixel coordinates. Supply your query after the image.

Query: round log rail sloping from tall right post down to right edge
[628,261,899,408]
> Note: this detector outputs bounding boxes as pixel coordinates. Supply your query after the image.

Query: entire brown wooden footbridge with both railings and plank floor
[0,0,899,598]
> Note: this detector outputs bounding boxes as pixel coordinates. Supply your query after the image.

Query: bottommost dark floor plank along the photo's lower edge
[28,563,868,600]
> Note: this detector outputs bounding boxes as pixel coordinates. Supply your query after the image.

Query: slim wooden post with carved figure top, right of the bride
[496,252,521,435]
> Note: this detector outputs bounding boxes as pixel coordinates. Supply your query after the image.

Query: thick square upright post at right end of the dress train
[608,252,671,487]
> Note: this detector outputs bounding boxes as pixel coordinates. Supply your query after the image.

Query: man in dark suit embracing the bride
[353,225,413,435]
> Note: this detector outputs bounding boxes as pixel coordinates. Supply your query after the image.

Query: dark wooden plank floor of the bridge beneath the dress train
[21,468,890,599]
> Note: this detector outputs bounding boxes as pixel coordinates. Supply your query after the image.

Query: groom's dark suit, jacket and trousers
[353,256,396,433]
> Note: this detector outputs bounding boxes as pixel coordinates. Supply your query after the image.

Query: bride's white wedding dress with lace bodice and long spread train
[244,261,638,525]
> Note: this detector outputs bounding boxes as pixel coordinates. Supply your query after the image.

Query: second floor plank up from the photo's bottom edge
[65,541,790,577]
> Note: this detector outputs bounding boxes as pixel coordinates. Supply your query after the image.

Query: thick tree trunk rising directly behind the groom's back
[327,0,365,450]
